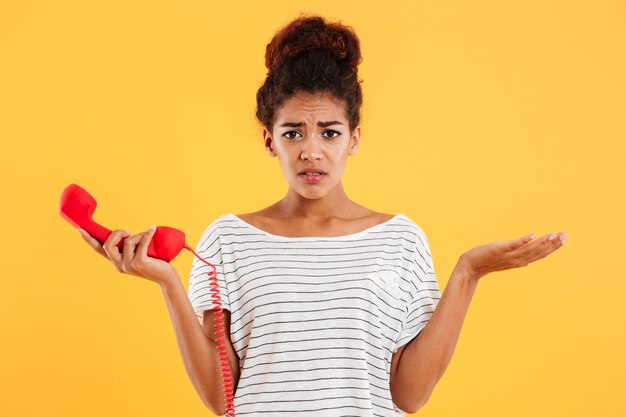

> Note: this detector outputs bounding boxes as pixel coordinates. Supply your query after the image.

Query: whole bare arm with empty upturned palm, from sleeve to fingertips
[390,232,567,412]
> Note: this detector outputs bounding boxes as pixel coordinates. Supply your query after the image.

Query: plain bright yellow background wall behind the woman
[0,0,626,417]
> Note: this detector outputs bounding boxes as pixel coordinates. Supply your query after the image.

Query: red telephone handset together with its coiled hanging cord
[59,184,235,417]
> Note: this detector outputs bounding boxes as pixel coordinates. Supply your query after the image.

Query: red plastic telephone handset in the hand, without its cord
[59,184,185,262]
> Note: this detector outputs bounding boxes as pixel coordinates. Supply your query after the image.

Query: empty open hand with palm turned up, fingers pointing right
[461,232,567,279]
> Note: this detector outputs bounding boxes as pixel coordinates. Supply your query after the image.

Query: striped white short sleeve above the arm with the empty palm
[394,227,441,352]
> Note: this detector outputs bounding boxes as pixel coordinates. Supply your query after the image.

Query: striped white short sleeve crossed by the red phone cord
[187,219,230,323]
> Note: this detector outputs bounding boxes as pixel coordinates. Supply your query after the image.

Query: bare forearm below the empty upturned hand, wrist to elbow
[393,258,478,410]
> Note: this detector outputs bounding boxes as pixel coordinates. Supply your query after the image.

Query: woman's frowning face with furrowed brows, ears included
[263,92,361,199]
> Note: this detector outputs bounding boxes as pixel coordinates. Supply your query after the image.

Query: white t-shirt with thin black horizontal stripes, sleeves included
[188,213,440,417]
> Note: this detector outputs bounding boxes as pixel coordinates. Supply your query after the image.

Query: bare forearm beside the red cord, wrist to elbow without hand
[161,274,226,415]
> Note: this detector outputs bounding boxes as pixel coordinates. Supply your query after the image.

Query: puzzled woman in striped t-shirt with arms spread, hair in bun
[79,16,566,416]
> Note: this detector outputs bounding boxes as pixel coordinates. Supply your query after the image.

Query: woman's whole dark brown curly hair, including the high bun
[256,15,363,132]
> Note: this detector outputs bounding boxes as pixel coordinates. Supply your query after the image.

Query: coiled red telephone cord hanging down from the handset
[185,245,235,417]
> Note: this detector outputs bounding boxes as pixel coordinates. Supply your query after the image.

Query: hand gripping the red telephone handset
[77,227,178,285]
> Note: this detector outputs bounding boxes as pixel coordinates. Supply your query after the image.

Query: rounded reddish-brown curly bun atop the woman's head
[265,16,362,72]
